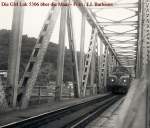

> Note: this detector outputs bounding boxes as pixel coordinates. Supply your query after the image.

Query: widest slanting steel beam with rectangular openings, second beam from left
[18,7,60,109]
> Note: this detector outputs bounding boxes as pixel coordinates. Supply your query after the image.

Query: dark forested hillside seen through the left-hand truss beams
[0,30,72,85]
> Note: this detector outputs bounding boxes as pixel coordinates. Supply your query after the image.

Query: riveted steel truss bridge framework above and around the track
[1,0,150,126]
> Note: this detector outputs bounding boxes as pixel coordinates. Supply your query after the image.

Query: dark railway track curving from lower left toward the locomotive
[0,94,122,128]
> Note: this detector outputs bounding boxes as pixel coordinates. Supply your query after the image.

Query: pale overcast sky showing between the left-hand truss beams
[0,0,91,50]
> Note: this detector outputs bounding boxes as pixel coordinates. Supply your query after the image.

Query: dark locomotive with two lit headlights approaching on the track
[107,67,130,94]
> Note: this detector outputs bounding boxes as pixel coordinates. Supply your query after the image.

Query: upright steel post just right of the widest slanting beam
[55,7,67,101]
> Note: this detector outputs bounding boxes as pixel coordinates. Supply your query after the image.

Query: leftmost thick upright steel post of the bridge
[6,0,24,107]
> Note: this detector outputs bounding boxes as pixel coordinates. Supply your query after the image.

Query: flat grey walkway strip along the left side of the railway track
[0,94,107,126]
